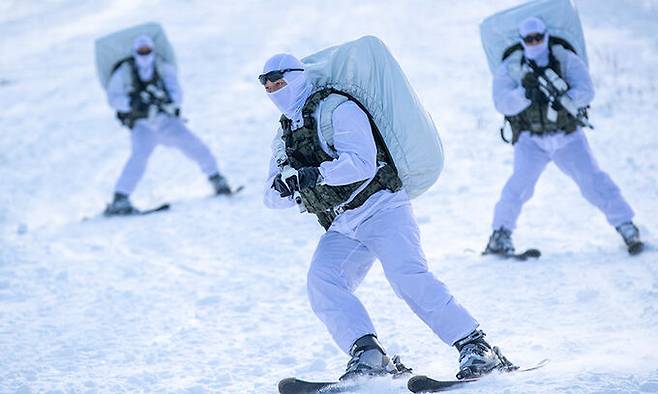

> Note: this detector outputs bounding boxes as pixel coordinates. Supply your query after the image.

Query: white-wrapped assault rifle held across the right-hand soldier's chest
[527,61,594,129]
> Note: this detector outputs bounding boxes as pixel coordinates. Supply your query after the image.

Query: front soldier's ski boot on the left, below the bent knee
[339,334,411,381]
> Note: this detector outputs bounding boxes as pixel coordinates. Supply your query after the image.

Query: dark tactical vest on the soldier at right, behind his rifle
[505,48,578,143]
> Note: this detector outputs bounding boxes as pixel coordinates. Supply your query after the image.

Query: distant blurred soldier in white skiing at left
[105,34,231,215]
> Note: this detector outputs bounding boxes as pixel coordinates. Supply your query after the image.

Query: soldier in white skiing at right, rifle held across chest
[485,17,643,255]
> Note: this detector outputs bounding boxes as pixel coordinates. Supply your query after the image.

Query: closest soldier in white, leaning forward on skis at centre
[259,54,509,380]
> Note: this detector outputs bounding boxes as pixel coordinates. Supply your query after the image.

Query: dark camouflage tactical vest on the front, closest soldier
[280,89,402,230]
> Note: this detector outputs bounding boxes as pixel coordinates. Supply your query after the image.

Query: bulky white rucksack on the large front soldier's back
[302,36,443,198]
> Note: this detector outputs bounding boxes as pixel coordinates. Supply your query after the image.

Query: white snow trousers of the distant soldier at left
[114,117,218,195]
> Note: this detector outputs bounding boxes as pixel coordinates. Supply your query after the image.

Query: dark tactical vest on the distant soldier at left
[113,57,173,129]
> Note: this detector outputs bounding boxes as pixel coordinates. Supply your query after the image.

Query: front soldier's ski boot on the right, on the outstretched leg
[454,330,518,380]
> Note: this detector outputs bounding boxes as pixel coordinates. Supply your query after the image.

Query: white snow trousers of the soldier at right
[492,129,633,230]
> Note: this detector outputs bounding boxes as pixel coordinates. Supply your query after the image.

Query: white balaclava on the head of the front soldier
[263,53,312,130]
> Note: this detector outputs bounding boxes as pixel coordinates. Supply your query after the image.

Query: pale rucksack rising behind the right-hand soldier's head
[480,0,587,73]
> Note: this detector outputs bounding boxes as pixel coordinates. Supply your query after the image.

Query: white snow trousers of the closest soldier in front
[307,204,478,354]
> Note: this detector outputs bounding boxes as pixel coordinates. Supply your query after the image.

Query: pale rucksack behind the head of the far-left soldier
[95,22,176,88]
